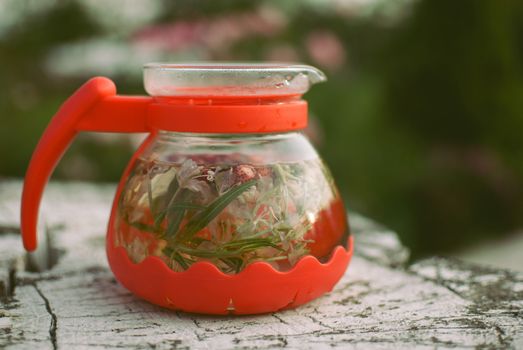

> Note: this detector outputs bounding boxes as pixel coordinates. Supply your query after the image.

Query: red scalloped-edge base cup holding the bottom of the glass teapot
[107,232,353,315]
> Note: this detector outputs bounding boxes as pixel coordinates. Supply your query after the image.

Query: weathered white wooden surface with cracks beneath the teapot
[0,181,523,349]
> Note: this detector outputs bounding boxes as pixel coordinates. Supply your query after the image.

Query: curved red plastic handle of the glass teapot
[20,77,152,251]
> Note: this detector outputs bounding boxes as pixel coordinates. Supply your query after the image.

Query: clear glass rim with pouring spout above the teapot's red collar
[144,62,326,97]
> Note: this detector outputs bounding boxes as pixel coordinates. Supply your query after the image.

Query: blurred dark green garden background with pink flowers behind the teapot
[0,0,523,258]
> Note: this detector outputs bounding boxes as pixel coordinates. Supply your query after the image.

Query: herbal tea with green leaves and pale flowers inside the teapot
[115,155,349,273]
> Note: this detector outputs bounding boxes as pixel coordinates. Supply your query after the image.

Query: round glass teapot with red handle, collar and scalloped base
[21,64,352,314]
